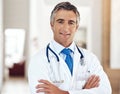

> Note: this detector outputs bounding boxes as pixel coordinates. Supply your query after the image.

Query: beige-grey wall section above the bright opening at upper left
[4,0,29,29]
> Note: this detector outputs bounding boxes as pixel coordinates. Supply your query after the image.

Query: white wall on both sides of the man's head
[30,0,102,61]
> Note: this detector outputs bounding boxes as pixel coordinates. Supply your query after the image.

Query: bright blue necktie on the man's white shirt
[61,48,73,75]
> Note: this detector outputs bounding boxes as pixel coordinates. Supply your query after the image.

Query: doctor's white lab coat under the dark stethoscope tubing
[28,42,112,94]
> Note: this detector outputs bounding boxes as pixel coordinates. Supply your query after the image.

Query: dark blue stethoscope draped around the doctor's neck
[46,43,85,65]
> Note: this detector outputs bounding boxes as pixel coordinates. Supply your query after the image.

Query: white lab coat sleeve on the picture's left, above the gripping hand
[28,54,49,94]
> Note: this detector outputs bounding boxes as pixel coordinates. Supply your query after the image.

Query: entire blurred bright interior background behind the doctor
[0,0,120,94]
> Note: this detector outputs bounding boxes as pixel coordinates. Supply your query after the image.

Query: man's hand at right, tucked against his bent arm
[83,75,100,89]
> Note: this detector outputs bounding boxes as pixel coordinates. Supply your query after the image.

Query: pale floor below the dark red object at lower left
[1,77,30,94]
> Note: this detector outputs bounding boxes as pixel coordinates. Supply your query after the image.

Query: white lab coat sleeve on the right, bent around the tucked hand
[69,54,112,94]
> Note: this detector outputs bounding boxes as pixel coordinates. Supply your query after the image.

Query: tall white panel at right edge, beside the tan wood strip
[110,0,120,69]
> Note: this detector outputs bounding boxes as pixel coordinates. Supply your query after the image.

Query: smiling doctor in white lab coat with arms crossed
[28,2,112,94]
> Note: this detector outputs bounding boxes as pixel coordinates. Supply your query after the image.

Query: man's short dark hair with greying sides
[50,2,80,25]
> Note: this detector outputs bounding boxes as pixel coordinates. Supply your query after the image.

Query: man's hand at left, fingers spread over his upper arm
[36,80,69,94]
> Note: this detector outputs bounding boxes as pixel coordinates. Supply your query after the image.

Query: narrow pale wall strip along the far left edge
[0,0,3,91]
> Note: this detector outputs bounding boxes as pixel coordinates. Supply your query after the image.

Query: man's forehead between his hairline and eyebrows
[55,9,77,20]
